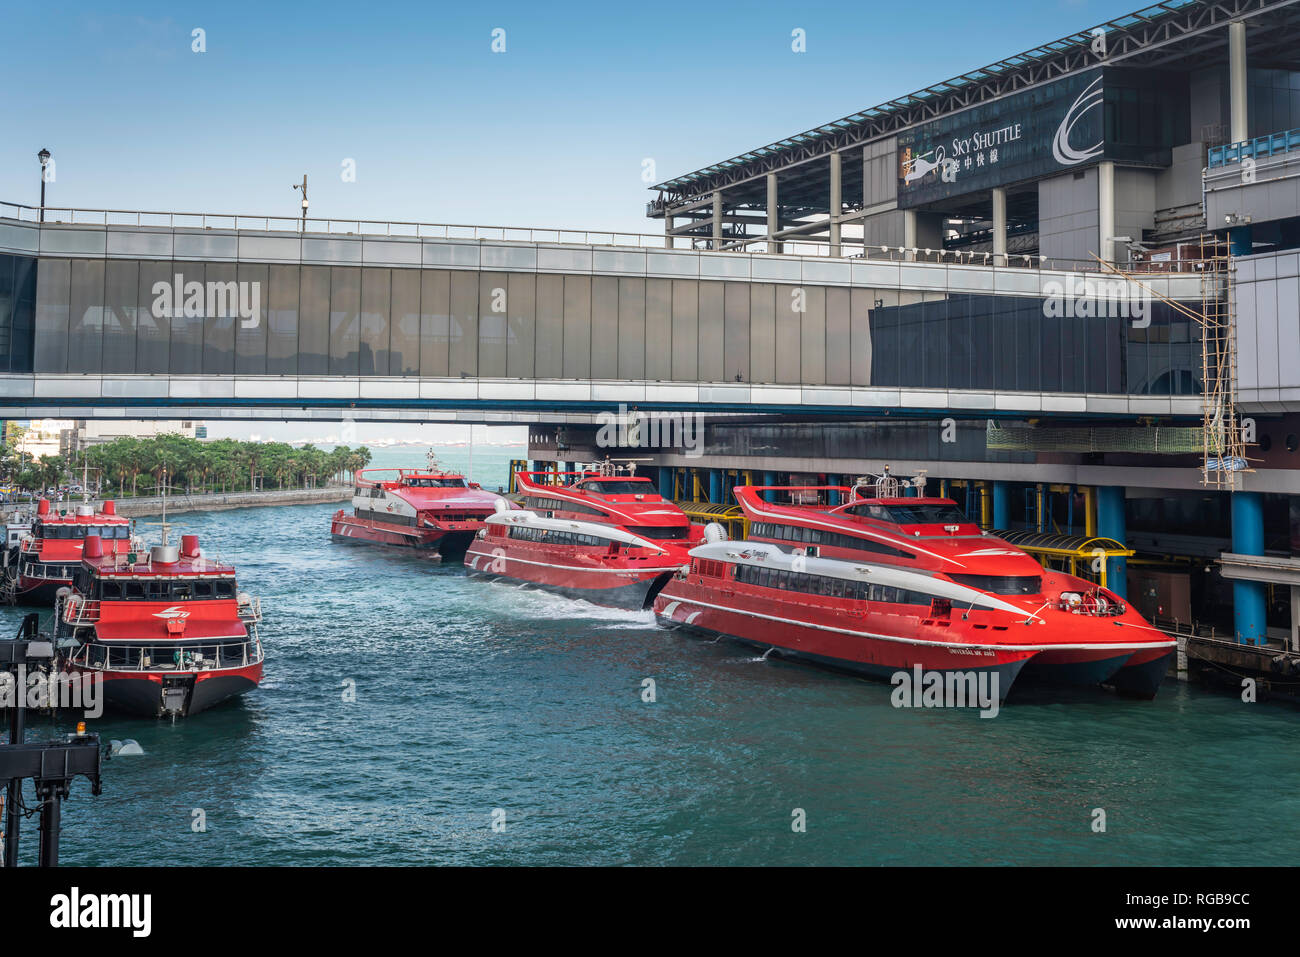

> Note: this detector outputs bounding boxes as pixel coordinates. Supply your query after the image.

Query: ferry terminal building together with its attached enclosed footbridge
[0,0,1300,684]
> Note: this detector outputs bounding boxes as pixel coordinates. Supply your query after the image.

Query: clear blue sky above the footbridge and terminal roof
[0,0,1140,233]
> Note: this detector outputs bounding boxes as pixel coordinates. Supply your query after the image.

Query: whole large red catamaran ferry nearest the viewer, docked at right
[654,475,1175,698]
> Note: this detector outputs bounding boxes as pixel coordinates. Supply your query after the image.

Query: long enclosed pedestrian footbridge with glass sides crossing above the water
[0,204,1201,420]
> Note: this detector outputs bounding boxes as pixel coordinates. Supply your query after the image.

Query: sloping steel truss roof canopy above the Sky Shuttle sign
[649,0,1300,209]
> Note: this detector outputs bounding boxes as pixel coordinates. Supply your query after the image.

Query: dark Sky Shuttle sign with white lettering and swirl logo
[898,69,1105,208]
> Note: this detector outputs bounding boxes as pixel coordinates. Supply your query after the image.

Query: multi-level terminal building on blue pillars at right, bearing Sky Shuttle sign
[634,1,1300,670]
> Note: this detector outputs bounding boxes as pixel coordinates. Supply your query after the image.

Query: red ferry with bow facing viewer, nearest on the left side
[56,533,263,718]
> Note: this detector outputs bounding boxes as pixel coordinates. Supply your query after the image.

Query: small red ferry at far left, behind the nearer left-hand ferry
[5,498,131,605]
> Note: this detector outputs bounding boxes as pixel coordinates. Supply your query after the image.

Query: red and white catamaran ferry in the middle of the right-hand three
[465,463,702,609]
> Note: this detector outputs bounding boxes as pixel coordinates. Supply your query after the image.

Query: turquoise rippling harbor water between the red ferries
[0,451,1300,865]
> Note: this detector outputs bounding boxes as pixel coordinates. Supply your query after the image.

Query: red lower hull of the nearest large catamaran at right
[654,544,1173,697]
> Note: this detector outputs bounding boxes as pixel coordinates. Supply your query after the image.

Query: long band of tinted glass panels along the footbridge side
[27,256,1200,395]
